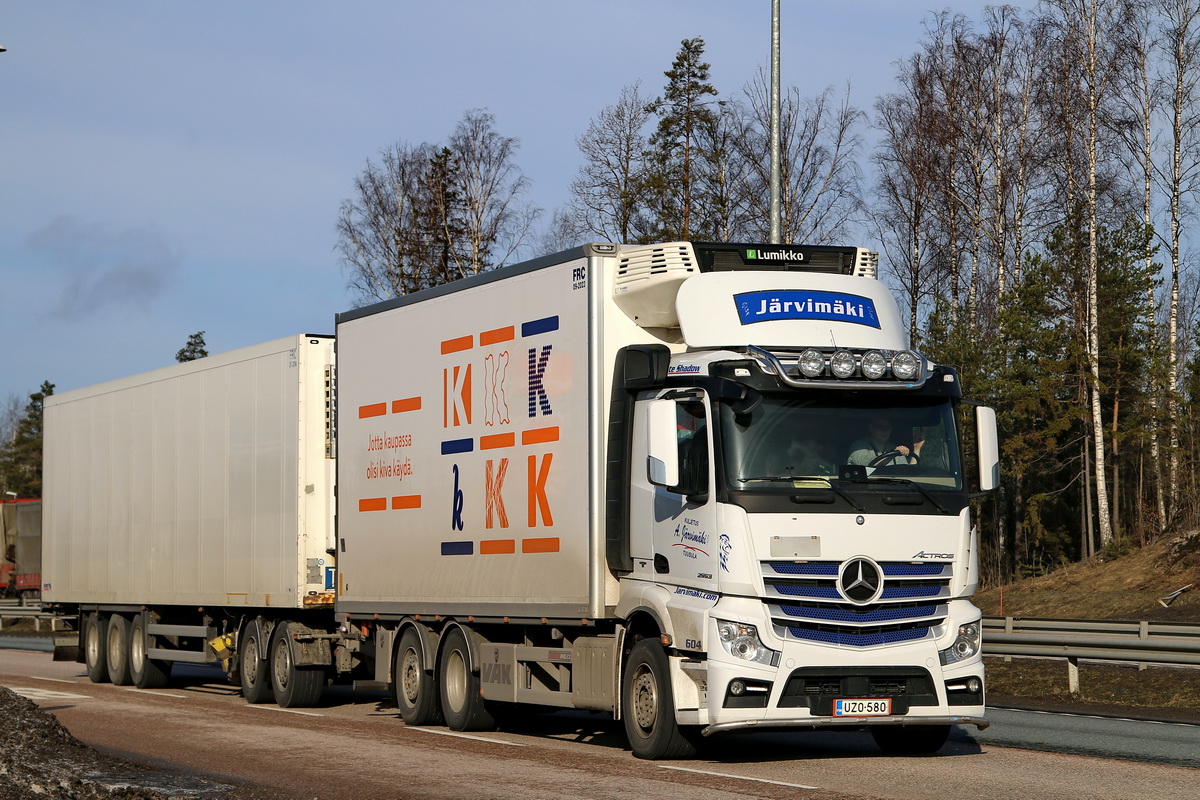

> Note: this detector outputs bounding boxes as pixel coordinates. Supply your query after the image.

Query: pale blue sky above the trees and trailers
[0,0,1017,404]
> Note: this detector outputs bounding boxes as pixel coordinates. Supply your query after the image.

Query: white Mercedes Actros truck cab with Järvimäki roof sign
[610,245,997,757]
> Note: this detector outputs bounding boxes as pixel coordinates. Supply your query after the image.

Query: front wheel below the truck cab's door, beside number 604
[620,639,696,759]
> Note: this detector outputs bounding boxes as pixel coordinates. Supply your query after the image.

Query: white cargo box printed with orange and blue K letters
[337,247,652,619]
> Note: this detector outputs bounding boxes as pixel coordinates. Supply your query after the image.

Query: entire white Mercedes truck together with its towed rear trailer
[46,242,998,758]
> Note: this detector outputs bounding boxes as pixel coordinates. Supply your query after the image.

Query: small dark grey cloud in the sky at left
[25,215,179,318]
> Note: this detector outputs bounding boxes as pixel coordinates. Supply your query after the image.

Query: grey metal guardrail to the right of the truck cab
[983,616,1200,693]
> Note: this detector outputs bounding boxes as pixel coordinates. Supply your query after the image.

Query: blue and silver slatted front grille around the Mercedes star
[762,561,954,648]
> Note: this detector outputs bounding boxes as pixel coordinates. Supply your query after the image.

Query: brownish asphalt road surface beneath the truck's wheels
[0,650,1200,800]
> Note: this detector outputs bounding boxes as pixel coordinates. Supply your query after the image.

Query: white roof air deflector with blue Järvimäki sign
[676,272,908,350]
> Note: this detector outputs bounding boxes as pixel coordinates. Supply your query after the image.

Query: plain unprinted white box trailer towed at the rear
[42,335,335,695]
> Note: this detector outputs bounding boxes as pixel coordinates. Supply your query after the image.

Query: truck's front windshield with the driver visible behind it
[721,392,962,492]
